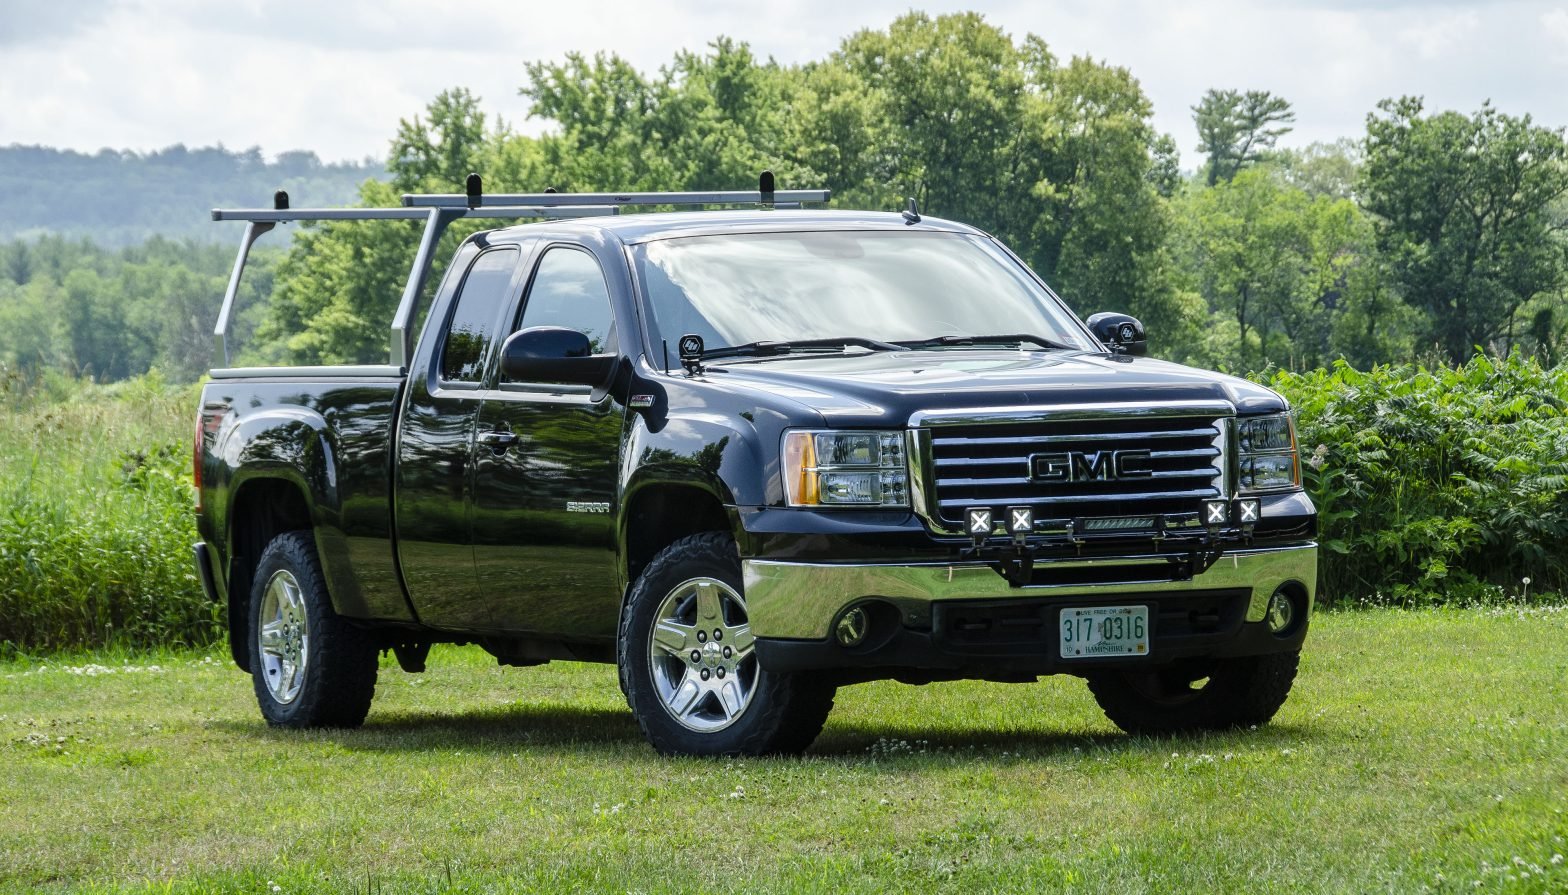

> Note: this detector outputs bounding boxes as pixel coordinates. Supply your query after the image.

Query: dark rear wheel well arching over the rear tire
[229,478,310,671]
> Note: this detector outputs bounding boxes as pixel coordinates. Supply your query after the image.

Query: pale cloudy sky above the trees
[0,0,1568,166]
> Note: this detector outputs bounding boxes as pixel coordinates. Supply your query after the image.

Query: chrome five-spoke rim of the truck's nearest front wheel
[648,578,757,734]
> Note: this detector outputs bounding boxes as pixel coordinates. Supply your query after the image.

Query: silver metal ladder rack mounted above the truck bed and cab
[212,171,833,368]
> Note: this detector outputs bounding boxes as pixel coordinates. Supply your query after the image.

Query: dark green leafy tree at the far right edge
[1361,97,1568,362]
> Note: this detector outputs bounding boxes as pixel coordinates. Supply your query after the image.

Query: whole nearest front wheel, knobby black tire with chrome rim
[616,533,836,755]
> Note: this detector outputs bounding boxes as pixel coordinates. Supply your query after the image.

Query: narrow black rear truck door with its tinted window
[397,238,522,629]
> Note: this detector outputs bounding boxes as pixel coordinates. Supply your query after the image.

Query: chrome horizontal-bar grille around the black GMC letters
[916,406,1226,530]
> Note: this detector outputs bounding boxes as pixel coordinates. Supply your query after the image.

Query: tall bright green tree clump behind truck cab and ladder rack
[262,13,1189,362]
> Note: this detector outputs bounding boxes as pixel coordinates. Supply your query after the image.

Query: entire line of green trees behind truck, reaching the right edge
[0,13,1568,382]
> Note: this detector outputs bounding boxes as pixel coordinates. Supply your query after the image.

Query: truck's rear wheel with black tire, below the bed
[248,531,378,727]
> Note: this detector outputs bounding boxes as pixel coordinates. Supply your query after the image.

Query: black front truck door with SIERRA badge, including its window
[474,246,626,640]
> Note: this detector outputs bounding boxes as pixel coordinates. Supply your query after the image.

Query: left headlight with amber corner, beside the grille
[782,431,909,506]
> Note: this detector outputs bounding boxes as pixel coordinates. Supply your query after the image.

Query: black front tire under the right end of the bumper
[1088,650,1301,735]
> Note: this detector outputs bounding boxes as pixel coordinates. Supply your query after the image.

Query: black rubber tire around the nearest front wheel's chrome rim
[616,531,837,755]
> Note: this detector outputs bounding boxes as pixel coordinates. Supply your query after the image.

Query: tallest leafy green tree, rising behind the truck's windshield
[827,13,1184,337]
